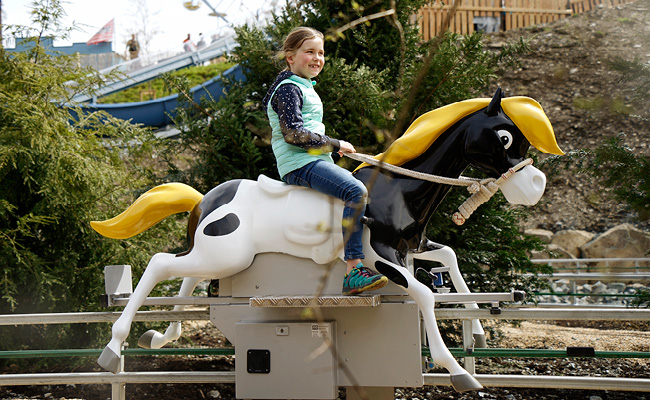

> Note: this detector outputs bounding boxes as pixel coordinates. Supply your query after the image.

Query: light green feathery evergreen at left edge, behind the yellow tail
[0,0,173,350]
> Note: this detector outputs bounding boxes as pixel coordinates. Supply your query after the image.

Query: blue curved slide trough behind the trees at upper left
[73,65,245,128]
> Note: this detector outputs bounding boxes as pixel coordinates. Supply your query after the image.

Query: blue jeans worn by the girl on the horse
[282,160,368,260]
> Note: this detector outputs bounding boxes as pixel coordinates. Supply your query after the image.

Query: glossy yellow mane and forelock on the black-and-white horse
[357,96,564,169]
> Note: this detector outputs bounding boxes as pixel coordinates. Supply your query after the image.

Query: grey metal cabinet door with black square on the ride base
[235,321,338,399]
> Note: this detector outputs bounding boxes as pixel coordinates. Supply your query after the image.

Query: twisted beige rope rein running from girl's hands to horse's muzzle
[343,153,533,225]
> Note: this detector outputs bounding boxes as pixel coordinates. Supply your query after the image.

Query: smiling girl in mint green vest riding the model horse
[264,27,388,295]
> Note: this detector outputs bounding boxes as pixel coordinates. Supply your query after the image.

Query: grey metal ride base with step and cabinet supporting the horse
[106,253,518,400]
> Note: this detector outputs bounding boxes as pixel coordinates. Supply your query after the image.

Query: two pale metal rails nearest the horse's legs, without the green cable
[0,298,650,400]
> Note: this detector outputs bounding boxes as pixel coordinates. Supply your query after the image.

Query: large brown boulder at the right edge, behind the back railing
[581,224,650,268]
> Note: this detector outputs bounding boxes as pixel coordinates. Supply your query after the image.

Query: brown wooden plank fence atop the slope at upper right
[415,0,633,40]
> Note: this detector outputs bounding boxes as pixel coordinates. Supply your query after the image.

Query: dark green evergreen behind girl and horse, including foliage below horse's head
[163,0,543,310]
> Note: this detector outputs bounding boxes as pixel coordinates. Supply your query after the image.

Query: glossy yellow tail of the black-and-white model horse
[90,183,203,239]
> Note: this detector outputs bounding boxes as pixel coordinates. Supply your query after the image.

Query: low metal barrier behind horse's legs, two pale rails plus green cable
[0,306,650,399]
